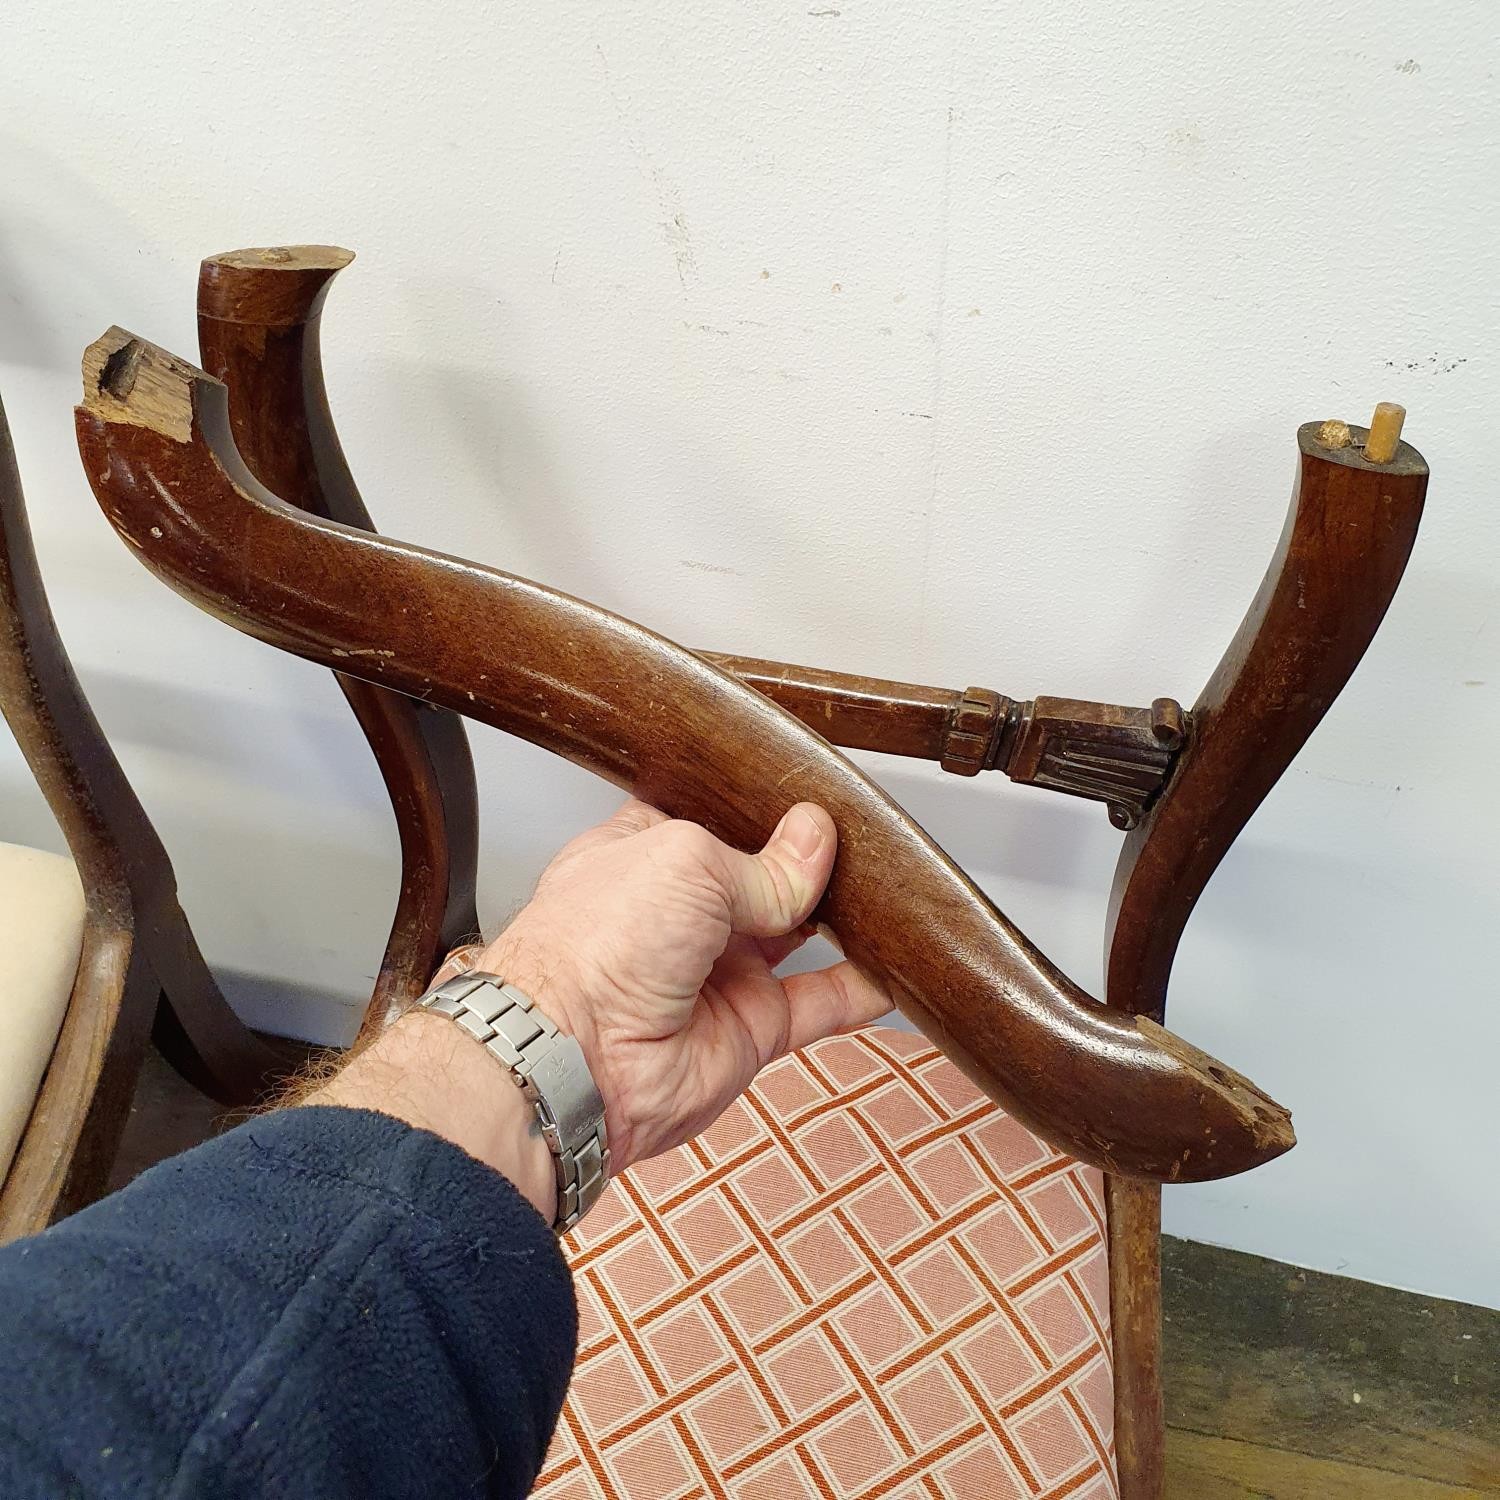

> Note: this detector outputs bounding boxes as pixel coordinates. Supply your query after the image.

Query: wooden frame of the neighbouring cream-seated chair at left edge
[0,390,285,1241]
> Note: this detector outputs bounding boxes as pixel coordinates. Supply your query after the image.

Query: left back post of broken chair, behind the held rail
[198,246,479,1031]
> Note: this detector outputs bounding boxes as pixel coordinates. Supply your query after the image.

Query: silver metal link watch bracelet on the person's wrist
[416,971,609,1235]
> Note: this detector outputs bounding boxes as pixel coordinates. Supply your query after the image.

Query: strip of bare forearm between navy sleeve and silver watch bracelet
[303,1011,557,1224]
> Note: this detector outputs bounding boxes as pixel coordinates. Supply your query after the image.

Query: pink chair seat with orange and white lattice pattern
[534,1028,1118,1500]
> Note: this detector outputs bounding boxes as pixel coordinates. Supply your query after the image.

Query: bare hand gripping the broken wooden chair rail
[434,801,891,1172]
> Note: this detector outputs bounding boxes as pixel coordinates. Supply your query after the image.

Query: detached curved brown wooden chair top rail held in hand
[78,330,1293,1181]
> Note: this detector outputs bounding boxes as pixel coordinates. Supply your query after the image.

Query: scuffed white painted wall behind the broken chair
[0,0,1500,1305]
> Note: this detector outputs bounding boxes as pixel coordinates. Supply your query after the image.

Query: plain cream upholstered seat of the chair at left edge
[0,843,84,1181]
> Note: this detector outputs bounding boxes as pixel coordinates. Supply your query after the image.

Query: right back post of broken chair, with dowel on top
[1106,423,1428,1500]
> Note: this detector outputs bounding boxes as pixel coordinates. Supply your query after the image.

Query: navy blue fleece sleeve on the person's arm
[0,1109,578,1500]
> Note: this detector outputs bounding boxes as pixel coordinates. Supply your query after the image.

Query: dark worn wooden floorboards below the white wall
[116,1056,1500,1500]
